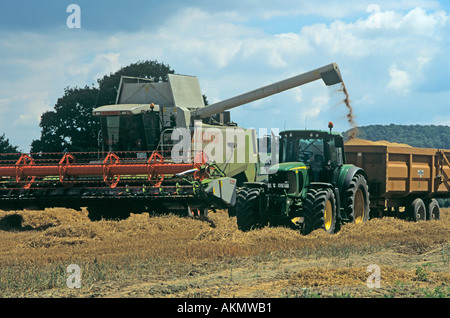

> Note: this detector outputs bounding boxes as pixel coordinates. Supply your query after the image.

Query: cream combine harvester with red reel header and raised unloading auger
[0,63,342,220]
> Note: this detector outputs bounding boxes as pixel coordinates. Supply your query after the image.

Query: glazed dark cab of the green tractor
[279,125,345,183]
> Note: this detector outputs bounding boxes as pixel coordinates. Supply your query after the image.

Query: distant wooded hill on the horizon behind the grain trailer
[343,124,450,149]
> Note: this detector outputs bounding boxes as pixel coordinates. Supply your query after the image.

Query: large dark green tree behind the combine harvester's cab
[31,61,174,152]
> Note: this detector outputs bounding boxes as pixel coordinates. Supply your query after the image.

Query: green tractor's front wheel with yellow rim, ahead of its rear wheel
[301,188,337,235]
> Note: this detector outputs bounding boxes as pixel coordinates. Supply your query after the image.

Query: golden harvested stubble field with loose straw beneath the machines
[0,209,450,298]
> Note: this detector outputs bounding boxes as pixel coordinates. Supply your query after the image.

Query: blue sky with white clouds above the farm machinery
[0,0,450,151]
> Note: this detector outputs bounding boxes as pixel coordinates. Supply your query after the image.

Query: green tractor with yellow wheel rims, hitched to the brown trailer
[236,122,369,234]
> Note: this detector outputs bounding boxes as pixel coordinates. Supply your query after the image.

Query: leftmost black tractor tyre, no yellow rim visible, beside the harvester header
[236,188,268,232]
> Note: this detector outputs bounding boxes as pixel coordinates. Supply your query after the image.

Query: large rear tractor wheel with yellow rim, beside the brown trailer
[344,174,370,224]
